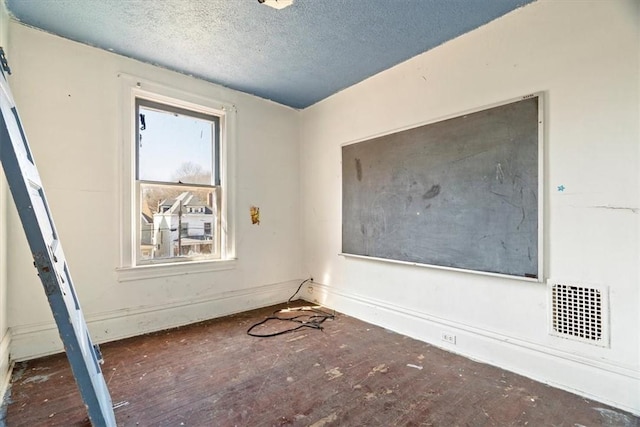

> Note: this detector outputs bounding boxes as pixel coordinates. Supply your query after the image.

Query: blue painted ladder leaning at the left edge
[0,48,116,426]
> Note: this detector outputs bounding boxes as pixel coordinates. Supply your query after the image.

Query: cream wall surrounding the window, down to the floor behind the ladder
[8,22,301,359]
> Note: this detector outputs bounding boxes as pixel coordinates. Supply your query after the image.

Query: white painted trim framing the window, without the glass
[116,73,237,281]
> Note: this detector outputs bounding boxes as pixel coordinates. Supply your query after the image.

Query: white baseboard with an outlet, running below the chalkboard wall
[301,283,640,415]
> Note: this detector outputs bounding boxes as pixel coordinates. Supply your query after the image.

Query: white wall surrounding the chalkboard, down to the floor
[301,0,640,413]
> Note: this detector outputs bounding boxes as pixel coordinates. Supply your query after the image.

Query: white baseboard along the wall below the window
[9,280,301,362]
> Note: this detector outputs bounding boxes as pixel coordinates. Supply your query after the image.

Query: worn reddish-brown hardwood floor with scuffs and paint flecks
[5,307,640,427]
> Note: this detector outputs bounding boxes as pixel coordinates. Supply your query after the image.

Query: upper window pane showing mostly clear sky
[138,105,215,185]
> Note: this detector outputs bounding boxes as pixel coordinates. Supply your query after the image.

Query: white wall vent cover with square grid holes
[549,283,609,347]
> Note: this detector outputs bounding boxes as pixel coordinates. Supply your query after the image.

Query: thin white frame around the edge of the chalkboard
[339,92,545,283]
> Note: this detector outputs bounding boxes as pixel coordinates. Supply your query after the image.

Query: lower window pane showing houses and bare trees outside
[140,183,219,260]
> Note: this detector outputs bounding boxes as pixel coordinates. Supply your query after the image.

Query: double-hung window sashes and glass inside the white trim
[135,97,221,264]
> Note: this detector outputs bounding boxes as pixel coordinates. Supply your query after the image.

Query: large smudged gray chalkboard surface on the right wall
[342,95,542,278]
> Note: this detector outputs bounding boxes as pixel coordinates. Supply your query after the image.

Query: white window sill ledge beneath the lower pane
[116,258,237,282]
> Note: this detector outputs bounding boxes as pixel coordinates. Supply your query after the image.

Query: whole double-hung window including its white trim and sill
[118,74,235,281]
